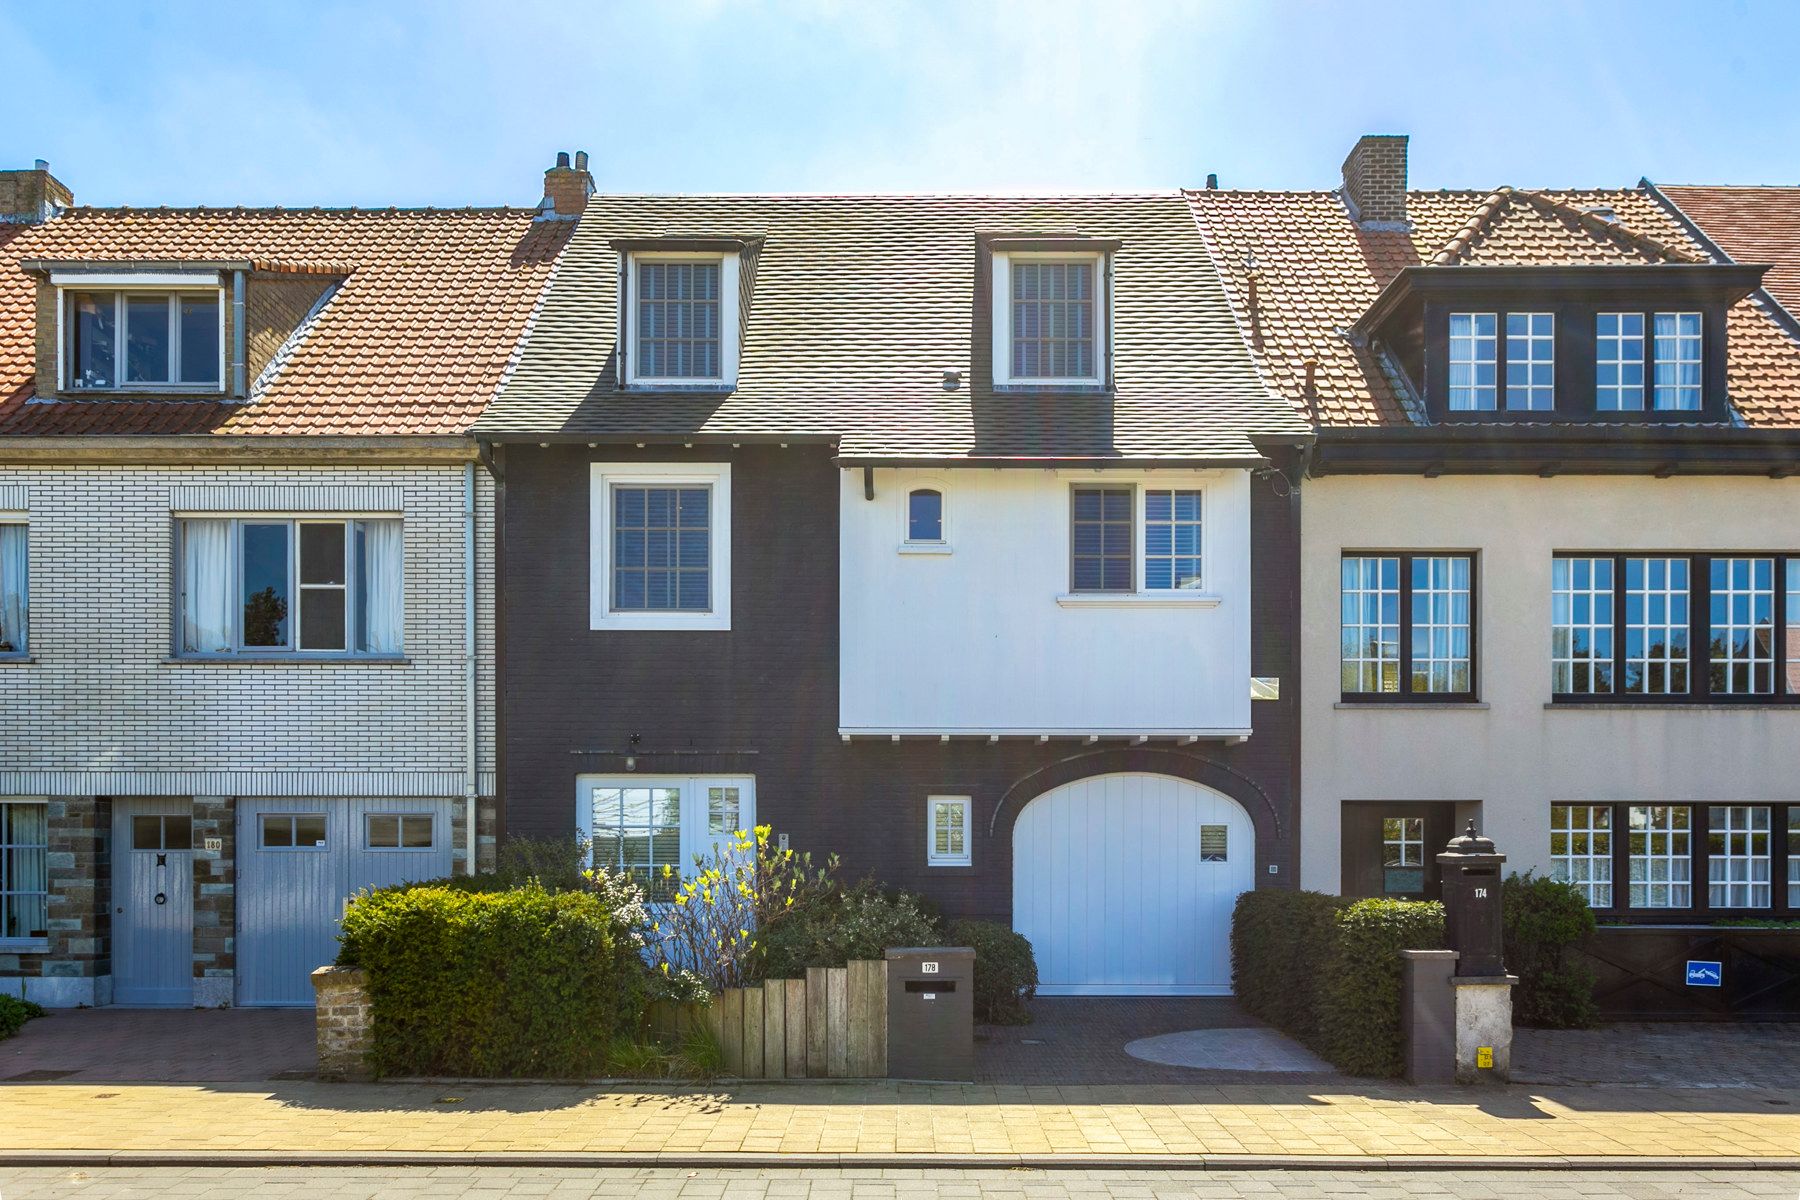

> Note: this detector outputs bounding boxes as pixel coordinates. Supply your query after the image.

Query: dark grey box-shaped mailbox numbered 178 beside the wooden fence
[887,946,976,1083]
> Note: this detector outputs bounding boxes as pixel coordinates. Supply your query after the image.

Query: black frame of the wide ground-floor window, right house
[1544,799,1800,925]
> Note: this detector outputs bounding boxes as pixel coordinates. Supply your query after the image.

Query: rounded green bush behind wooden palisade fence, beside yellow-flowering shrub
[758,880,941,979]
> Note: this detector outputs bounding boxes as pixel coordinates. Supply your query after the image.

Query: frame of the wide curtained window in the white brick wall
[171,511,407,662]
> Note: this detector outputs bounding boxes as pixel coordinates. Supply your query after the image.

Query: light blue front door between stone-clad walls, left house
[112,797,194,1007]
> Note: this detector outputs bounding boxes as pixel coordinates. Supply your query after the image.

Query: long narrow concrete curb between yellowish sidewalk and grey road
[0,1150,1800,1171]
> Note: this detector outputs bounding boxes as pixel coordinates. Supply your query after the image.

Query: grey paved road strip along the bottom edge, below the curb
[0,1168,1800,1200]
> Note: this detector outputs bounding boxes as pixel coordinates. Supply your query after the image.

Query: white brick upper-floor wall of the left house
[0,462,495,795]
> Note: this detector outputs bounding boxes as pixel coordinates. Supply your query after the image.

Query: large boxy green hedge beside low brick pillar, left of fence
[338,883,646,1078]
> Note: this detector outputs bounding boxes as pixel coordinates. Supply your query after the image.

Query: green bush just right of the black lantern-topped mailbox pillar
[1501,871,1600,1029]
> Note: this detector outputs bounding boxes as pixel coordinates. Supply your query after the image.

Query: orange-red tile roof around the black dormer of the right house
[1188,187,1800,426]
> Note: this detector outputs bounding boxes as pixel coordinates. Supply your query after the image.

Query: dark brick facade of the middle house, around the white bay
[499,444,1300,921]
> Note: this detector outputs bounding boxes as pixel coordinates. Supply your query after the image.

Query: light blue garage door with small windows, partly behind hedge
[238,799,452,1007]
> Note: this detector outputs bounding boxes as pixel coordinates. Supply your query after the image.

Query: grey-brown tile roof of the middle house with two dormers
[475,191,1307,461]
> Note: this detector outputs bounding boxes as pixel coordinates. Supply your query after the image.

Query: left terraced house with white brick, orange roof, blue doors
[0,164,571,1006]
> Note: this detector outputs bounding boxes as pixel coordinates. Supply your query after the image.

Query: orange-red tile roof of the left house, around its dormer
[0,209,572,437]
